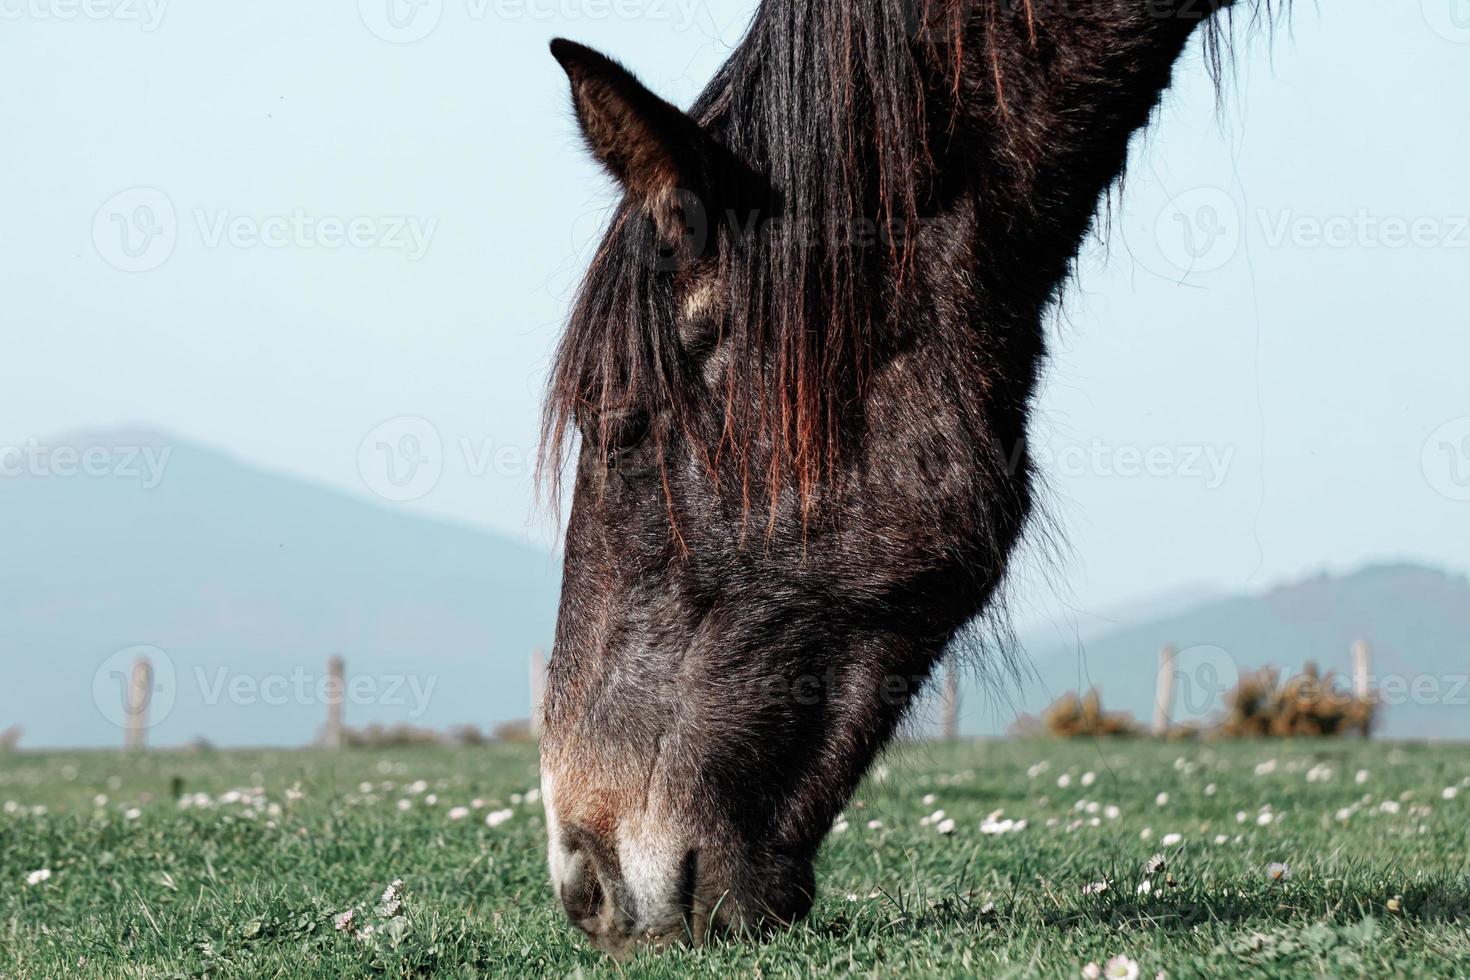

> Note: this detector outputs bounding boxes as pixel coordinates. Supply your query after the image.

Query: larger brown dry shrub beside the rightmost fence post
[1214,663,1377,738]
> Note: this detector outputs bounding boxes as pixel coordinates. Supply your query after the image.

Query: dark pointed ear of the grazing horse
[551,38,719,241]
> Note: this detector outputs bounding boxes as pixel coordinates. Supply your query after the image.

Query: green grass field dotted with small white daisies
[0,742,1470,977]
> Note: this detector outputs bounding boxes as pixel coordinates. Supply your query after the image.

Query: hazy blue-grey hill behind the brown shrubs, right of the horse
[963,564,1470,739]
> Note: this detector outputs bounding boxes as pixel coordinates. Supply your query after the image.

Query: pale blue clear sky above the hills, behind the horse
[0,0,1470,620]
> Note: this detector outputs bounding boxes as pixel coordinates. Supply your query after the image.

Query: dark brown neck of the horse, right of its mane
[929,0,1232,311]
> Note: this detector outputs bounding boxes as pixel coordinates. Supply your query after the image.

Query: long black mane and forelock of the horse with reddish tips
[538,0,1280,520]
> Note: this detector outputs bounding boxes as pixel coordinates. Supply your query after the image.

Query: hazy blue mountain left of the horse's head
[0,432,560,746]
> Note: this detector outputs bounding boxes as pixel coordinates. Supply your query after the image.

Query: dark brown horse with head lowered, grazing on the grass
[541,0,1264,955]
